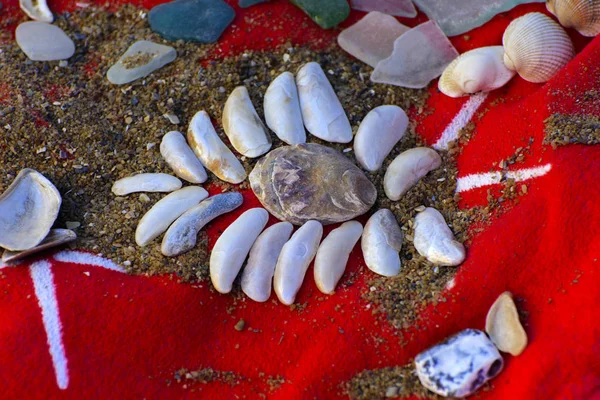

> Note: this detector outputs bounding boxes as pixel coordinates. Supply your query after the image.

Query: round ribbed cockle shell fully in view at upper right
[502,13,575,82]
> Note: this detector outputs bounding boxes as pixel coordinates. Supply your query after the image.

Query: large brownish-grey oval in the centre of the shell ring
[250,143,377,225]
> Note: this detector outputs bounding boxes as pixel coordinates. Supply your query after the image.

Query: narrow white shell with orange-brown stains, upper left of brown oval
[187,111,246,184]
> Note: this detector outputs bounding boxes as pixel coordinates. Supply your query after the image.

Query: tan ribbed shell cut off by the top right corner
[546,0,600,37]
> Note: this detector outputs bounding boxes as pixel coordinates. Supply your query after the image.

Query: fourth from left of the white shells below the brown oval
[315,221,362,294]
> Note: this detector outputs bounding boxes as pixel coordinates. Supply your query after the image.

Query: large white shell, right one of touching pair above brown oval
[296,62,352,143]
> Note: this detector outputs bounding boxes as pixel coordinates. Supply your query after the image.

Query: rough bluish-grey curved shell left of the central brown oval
[160,192,244,257]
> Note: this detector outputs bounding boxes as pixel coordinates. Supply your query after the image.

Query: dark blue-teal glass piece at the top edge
[148,0,235,43]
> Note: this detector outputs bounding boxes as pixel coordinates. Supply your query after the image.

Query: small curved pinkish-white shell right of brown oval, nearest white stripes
[383,147,442,201]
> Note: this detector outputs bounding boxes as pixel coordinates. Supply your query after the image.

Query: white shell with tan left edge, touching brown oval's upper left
[223,86,271,158]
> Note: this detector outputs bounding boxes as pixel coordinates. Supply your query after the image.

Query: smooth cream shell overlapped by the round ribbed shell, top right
[438,46,516,97]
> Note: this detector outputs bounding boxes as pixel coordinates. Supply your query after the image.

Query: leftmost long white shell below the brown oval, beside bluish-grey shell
[210,208,269,293]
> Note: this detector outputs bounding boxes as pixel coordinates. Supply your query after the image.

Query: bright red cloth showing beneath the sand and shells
[0,0,600,400]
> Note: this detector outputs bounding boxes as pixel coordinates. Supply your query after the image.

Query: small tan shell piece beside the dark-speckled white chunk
[485,292,527,356]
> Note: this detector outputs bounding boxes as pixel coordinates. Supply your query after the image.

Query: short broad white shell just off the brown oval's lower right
[361,208,402,276]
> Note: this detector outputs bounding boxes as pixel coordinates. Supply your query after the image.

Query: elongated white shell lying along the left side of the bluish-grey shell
[135,186,208,247]
